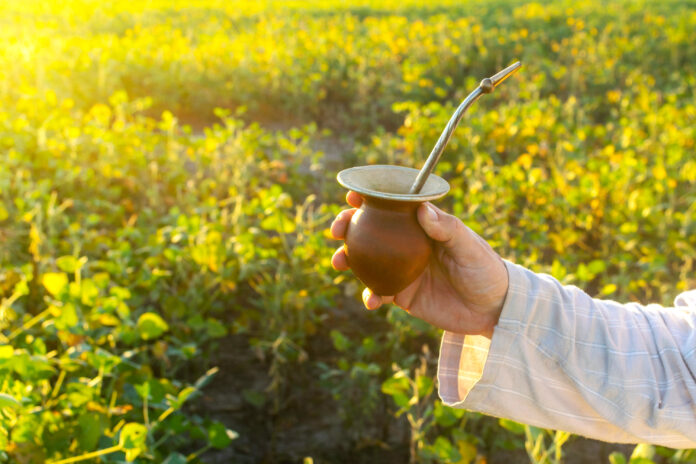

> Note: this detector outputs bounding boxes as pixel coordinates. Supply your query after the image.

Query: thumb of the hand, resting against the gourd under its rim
[418,203,479,263]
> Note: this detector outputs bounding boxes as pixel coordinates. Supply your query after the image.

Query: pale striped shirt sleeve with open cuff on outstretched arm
[438,262,696,448]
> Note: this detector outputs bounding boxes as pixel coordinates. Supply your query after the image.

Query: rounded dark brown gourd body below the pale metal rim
[344,195,432,296]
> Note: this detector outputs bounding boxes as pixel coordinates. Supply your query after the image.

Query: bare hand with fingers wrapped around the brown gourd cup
[331,192,508,338]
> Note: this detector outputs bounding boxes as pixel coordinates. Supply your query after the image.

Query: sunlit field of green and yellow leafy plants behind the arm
[0,0,696,464]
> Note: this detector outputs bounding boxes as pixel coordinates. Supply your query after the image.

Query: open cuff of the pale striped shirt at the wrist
[437,260,530,409]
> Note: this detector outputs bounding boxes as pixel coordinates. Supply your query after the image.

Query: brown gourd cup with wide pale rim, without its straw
[338,165,449,295]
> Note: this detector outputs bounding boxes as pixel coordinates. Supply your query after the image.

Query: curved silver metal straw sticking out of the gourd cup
[408,61,522,193]
